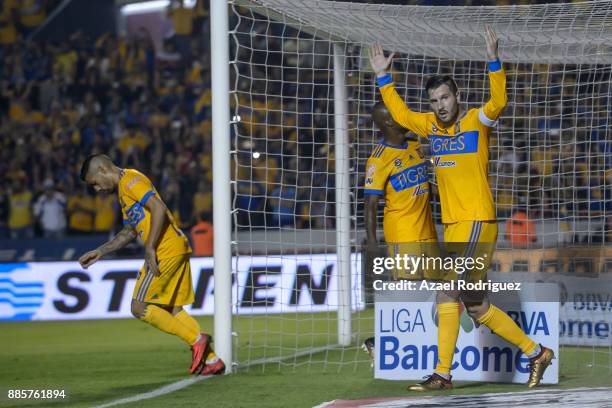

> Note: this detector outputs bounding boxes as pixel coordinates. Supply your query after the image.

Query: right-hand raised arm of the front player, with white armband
[478,26,508,127]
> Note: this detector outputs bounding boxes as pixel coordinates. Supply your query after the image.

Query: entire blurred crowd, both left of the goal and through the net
[0,0,612,245]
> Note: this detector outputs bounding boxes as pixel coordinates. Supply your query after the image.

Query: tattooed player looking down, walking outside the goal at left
[79,154,225,375]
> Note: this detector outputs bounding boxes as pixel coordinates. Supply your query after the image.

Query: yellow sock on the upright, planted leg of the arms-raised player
[435,303,459,379]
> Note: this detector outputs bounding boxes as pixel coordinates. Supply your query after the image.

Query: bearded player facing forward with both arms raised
[370,27,554,391]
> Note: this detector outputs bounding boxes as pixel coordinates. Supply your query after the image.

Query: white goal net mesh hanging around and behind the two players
[230,0,612,369]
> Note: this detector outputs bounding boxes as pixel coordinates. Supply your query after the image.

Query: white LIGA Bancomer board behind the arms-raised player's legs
[375,299,559,384]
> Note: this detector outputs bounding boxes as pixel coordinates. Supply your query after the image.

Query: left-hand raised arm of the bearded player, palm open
[370,43,427,137]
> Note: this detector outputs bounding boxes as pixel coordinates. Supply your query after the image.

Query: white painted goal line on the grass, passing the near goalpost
[94,346,337,408]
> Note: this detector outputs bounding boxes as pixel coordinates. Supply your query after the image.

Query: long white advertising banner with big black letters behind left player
[0,254,364,320]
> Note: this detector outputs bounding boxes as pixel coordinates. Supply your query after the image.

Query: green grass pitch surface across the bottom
[0,310,612,407]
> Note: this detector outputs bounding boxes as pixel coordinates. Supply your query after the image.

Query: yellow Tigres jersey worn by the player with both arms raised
[378,61,507,224]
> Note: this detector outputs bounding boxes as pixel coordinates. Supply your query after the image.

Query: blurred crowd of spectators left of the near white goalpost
[0,0,212,238]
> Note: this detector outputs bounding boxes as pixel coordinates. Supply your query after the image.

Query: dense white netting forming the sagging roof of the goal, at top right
[236,0,612,64]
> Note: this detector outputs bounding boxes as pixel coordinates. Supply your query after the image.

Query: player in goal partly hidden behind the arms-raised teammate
[363,102,437,358]
